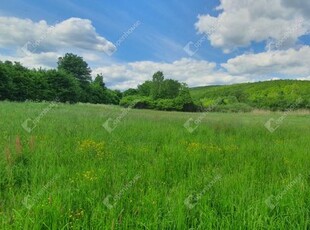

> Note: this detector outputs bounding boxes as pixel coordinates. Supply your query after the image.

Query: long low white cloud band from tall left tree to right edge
[94,46,310,90]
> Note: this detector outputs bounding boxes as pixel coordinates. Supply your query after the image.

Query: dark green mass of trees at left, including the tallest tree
[0,54,122,104]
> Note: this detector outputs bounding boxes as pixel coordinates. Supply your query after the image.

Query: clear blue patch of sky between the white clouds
[2,0,226,61]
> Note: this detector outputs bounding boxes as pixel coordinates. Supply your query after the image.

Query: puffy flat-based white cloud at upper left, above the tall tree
[0,17,115,53]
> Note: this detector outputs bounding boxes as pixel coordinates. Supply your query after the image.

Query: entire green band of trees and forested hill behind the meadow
[0,53,310,112]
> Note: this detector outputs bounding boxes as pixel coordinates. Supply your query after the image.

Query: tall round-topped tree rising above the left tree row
[57,53,91,86]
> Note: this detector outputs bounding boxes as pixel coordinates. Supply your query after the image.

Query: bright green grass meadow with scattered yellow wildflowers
[0,102,310,230]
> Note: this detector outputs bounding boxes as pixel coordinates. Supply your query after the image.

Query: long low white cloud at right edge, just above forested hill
[222,46,310,77]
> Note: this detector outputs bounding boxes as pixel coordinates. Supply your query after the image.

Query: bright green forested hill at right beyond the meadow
[190,80,310,111]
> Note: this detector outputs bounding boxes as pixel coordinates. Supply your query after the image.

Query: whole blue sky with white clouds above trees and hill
[0,0,310,90]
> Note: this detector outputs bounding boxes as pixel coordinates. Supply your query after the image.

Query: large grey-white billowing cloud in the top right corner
[195,0,310,53]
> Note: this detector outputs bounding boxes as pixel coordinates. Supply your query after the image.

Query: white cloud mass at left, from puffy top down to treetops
[0,17,115,69]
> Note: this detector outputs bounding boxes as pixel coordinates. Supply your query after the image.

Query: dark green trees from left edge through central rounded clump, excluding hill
[0,53,195,110]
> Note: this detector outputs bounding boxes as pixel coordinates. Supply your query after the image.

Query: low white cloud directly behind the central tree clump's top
[93,58,251,90]
